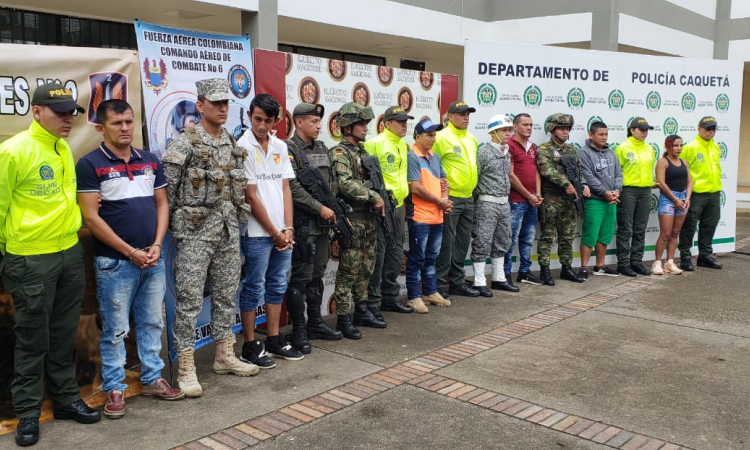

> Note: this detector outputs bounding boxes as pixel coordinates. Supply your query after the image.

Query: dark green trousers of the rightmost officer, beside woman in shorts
[680,192,721,258]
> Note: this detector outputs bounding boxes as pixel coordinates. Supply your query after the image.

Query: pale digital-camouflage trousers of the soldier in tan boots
[174,226,240,352]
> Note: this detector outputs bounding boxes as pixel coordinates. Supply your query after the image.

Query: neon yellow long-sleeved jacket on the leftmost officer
[0,120,81,256]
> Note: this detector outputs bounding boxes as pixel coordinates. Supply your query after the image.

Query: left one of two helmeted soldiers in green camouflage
[329,103,385,339]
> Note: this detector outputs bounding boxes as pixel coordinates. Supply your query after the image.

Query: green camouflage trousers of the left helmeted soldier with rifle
[333,220,378,316]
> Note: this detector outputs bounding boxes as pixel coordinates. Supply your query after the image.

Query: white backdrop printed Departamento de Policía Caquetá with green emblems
[463,40,743,266]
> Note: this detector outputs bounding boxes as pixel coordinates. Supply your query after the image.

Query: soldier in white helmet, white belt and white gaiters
[471,114,519,297]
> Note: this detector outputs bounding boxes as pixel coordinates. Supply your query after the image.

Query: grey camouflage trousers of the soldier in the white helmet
[471,200,511,262]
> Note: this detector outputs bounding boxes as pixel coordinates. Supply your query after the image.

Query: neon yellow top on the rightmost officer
[680,135,721,193]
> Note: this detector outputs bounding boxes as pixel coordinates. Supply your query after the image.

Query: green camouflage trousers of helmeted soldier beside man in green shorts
[536,196,577,266]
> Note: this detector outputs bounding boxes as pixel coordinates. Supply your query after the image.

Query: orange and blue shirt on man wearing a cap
[406,144,445,225]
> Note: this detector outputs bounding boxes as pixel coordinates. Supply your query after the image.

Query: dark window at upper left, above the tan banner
[0,8,137,49]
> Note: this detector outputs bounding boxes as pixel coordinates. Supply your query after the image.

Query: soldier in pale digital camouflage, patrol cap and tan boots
[162,78,258,397]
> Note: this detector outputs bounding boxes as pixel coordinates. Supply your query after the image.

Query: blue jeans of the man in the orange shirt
[406,221,443,300]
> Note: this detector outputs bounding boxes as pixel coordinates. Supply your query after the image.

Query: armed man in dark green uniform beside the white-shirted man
[286,103,342,353]
